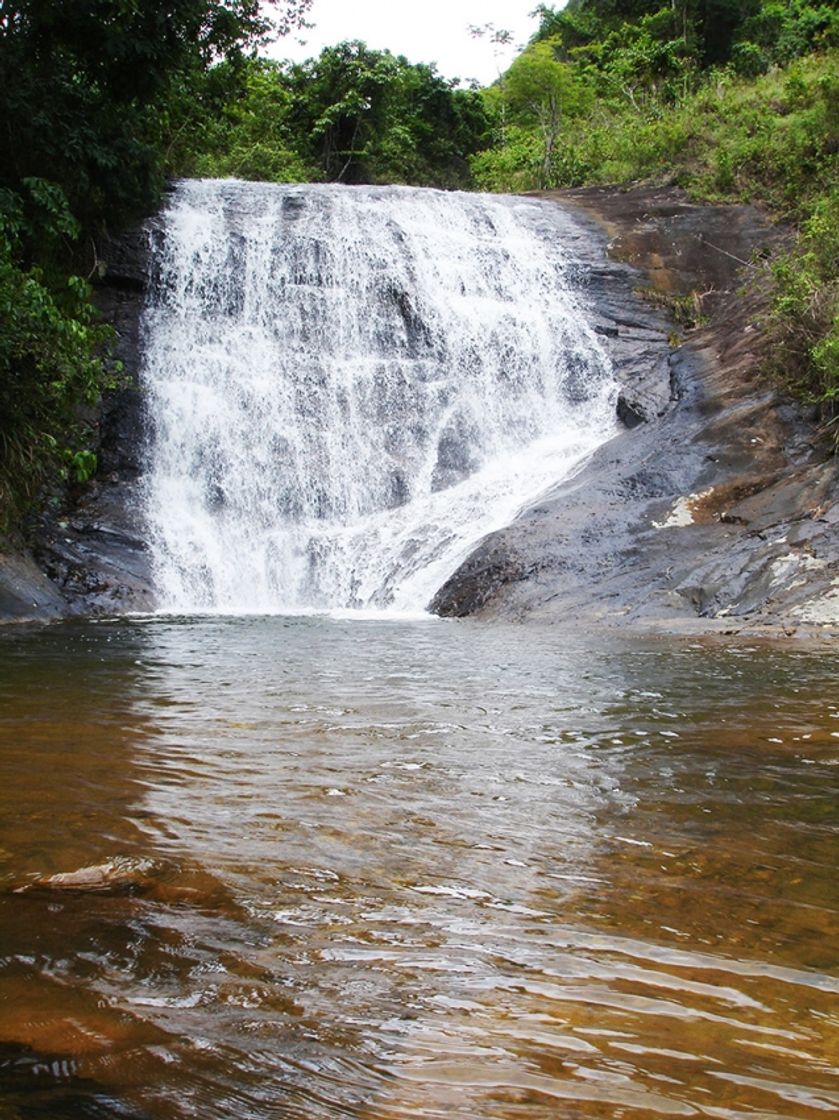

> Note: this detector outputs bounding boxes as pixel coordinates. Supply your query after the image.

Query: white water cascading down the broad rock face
[143,180,616,613]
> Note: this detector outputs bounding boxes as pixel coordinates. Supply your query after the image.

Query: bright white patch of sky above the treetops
[269,0,546,85]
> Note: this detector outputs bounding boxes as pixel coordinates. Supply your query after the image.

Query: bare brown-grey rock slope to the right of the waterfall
[431,189,839,633]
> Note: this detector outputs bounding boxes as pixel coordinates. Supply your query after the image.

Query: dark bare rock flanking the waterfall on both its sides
[0,188,839,633]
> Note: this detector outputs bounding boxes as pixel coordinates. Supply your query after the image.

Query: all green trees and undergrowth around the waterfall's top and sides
[0,0,839,529]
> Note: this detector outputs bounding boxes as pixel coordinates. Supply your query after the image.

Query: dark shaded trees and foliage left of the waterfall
[0,0,309,529]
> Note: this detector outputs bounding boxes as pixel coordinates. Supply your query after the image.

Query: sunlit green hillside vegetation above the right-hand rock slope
[472,0,839,441]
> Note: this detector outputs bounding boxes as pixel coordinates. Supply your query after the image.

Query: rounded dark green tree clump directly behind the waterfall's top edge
[170,41,487,187]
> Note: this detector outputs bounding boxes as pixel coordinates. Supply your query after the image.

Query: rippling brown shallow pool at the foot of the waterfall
[0,618,839,1120]
